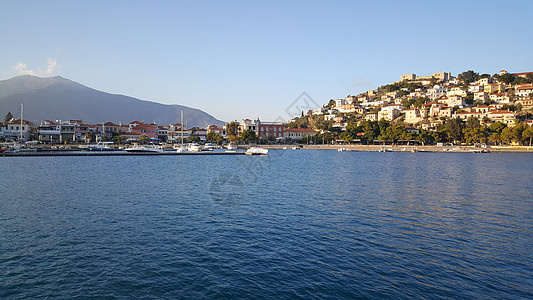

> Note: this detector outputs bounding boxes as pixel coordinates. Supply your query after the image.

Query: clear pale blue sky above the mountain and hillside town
[0,0,533,121]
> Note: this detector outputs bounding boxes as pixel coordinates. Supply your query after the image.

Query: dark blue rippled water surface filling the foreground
[0,150,533,299]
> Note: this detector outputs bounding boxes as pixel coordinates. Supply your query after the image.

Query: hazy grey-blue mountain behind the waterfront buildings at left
[0,75,224,128]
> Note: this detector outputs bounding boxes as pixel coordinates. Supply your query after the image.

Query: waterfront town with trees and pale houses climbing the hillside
[0,70,533,145]
